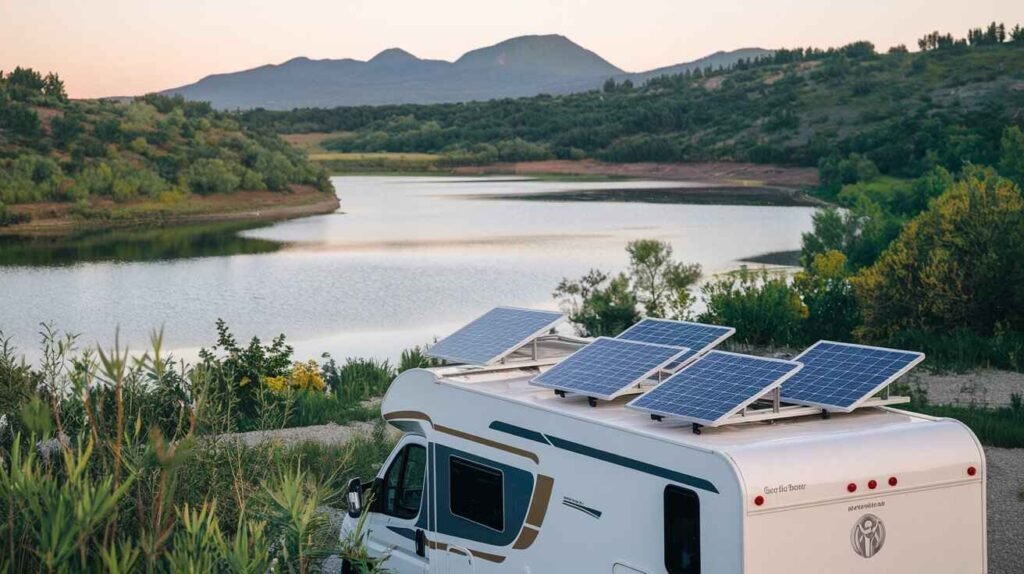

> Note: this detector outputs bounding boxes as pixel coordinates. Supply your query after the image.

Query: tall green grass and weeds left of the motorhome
[0,328,393,573]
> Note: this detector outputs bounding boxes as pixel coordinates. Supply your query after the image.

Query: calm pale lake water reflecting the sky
[0,177,813,359]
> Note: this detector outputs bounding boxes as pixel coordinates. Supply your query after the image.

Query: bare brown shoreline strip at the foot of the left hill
[0,185,340,236]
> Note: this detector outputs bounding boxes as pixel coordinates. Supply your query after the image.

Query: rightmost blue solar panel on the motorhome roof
[782,341,925,412]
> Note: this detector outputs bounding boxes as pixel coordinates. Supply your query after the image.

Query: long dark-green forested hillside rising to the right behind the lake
[242,24,1024,181]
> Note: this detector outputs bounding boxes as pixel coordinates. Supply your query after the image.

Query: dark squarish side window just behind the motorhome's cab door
[449,456,505,532]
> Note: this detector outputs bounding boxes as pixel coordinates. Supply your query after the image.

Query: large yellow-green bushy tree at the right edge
[853,168,1024,341]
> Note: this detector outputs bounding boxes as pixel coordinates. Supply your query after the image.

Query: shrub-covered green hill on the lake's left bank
[0,68,337,234]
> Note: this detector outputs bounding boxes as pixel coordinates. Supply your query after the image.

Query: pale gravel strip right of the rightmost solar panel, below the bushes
[906,369,1024,406]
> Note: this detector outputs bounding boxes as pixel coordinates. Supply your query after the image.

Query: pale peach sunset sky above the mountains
[6,0,1024,97]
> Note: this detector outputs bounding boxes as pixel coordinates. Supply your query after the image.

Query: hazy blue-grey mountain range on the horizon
[163,35,768,109]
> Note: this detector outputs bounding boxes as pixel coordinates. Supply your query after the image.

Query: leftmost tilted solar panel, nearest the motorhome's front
[425,307,563,365]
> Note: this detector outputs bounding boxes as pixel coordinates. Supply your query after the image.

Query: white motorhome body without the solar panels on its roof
[342,360,986,574]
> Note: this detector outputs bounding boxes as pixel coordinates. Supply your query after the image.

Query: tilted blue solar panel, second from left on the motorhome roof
[530,337,688,400]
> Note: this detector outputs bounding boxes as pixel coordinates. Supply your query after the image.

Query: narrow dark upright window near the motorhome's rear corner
[665,486,700,574]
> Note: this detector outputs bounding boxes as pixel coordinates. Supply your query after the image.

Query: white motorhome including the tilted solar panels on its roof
[342,310,986,574]
